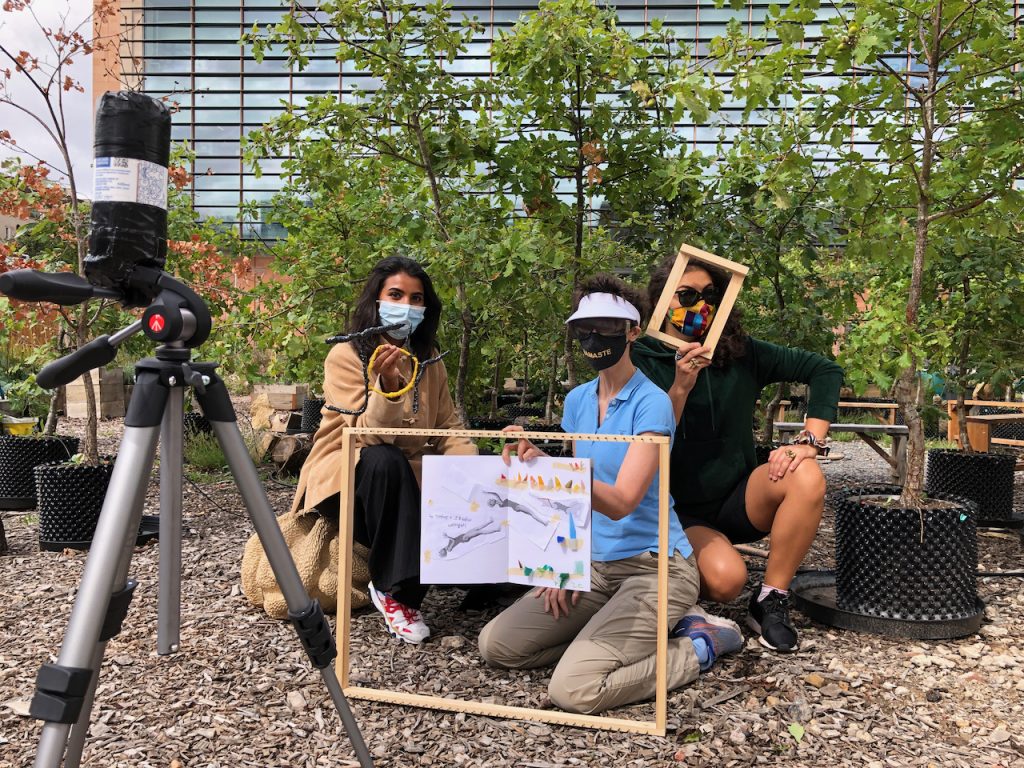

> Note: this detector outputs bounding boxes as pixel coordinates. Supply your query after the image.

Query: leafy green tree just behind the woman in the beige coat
[244,0,509,417]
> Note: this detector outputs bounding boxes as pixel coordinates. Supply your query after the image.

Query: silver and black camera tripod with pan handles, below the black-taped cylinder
[0,267,373,768]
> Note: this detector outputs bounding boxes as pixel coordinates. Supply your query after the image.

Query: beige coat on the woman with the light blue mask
[292,337,477,512]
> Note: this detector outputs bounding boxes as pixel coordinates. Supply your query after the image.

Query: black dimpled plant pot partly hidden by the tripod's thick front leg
[36,461,114,552]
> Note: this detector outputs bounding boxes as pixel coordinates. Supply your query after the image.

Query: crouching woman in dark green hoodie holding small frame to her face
[632,257,843,652]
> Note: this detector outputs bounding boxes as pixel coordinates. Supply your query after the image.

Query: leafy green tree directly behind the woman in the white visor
[493,0,721,387]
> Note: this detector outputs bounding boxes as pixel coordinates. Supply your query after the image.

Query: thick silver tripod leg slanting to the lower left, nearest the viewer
[31,427,158,768]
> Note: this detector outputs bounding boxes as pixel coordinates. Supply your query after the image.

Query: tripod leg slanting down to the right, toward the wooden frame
[197,377,373,768]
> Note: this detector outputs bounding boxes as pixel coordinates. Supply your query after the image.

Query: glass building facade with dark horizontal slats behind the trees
[120,0,839,238]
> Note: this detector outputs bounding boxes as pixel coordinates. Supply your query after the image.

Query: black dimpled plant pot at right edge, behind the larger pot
[925,449,1020,526]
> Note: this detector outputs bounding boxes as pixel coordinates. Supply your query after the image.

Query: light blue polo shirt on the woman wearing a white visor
[562,371,693,562]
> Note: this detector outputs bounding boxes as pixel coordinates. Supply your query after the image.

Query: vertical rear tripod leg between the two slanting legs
[157,387,184,655]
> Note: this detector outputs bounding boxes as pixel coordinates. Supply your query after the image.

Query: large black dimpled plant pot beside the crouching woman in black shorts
[833,484,978,622]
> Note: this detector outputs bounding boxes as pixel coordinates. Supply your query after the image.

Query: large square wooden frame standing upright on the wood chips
[336,427,669,736]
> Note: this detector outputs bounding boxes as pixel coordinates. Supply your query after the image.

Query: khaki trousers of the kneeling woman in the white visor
[479,552,699,714]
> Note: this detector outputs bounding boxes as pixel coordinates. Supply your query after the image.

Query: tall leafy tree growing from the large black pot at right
[719,0,1024,508]
